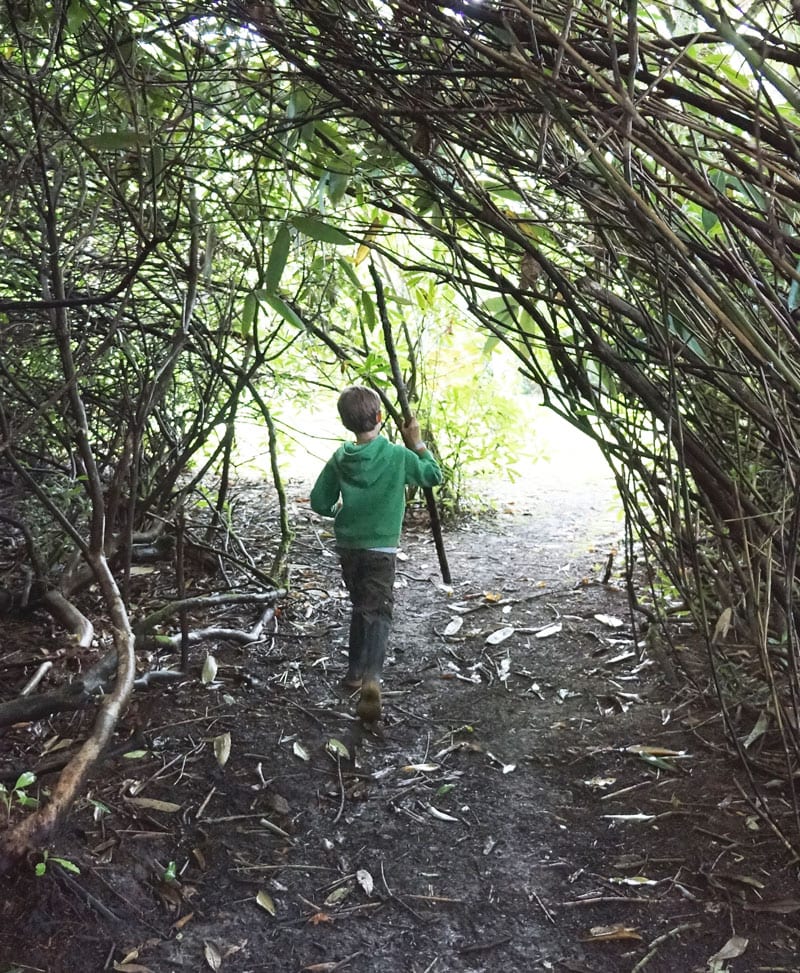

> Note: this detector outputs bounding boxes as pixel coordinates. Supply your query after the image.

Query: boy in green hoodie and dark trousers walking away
[310,386,442,723]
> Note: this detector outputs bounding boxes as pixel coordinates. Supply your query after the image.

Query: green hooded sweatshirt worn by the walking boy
[310,436,442,550]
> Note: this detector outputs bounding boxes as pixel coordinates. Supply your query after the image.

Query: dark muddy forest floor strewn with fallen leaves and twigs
[0,444,800,973]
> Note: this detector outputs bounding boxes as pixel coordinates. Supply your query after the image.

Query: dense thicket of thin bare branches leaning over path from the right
[231,0,800,792]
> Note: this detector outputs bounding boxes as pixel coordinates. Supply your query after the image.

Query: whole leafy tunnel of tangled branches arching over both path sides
[0,0,800,864]
